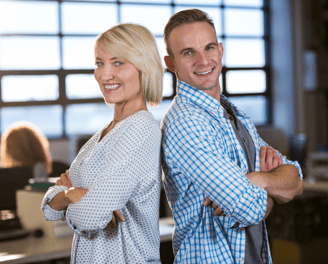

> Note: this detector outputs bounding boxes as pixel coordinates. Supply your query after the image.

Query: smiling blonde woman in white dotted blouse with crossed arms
[42,24,163,263]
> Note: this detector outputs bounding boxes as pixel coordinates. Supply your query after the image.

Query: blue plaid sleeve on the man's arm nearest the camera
[164,118,267,226]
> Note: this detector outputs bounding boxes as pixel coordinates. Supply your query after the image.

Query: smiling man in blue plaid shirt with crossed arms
[161,9,303,263]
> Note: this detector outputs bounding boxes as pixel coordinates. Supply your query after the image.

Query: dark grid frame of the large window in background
[0,0,273,138]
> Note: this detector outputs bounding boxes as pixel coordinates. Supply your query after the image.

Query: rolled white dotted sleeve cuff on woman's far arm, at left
[41,186,68,221]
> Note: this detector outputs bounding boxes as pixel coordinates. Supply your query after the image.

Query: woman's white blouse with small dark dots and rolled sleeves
[42,111,161,264]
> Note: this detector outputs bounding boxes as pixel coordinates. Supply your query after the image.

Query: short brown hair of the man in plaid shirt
[164,9,215,58]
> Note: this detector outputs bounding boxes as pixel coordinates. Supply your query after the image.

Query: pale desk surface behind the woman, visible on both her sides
[0,222,173,264]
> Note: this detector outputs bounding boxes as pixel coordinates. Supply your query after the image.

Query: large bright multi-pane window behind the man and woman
[0,0,271,138]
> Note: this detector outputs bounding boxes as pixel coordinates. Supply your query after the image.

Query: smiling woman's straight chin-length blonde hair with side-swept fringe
[96,23,164,105]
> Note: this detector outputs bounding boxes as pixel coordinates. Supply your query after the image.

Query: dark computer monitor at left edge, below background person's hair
[0,167,33,211]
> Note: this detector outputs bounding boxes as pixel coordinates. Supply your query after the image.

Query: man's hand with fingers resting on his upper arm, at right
[260,146,283,171]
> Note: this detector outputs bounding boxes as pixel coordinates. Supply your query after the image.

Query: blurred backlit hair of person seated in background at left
[1,121,52,174]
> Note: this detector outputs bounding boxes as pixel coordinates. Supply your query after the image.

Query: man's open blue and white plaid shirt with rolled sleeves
[161,81,302,264]
